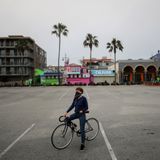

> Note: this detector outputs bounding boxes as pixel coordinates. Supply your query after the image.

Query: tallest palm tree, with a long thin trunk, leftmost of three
[52,23,68,85]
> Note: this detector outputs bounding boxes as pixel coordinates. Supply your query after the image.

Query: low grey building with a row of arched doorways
[117,51,160,84]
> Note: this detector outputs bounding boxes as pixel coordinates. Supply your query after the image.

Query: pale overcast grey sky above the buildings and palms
[0,0,160,65]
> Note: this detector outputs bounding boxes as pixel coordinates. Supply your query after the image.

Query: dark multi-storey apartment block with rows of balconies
[0,36,46,85]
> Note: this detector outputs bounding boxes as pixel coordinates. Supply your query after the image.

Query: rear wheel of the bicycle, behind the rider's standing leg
[85,118,99,141]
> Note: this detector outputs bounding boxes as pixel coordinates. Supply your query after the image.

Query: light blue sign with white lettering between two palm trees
[91,70,115,76]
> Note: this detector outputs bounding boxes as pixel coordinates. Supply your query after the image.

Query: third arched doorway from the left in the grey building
[146,66,156,81]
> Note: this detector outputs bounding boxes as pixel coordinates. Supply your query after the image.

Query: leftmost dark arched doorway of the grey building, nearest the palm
[123,66,133,83]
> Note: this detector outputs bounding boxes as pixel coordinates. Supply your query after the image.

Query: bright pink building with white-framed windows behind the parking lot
[64,63,89,84]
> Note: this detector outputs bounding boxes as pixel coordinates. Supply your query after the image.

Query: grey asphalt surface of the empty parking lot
[0,86,160,160]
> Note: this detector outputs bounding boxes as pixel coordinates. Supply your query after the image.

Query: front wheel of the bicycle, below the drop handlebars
[51,124,73,149]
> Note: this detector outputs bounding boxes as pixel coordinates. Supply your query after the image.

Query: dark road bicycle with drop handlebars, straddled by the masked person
[51,112,99,150]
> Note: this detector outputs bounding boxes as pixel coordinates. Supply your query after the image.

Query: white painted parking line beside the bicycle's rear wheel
[99,122,117,160]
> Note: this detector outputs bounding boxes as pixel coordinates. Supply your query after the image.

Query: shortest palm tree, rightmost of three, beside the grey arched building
[107,38,123,84]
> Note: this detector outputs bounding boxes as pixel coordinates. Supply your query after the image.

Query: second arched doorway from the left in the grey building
[135,66,144,84]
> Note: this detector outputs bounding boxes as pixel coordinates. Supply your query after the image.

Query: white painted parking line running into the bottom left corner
[0,123,35,158]
